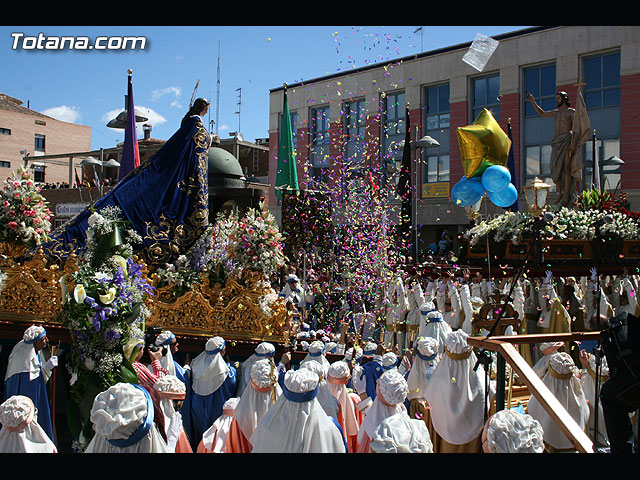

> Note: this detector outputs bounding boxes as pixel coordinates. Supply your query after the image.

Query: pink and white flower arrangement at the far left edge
[0,167,51,247]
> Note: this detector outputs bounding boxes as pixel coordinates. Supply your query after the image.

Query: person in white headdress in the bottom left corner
[0,395,58,453]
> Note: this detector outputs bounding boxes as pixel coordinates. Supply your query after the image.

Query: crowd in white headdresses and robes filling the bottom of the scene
[0,256,640,453]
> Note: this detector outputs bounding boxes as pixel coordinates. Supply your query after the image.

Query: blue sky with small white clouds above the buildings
[0,25,526,149]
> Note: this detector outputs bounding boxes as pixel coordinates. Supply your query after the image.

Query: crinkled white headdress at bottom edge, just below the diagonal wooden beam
[482,409,544,453]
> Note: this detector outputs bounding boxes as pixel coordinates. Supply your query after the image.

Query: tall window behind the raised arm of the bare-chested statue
[518,63,556,192]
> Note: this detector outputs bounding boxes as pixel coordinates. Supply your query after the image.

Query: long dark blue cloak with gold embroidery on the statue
[42,116,210,266]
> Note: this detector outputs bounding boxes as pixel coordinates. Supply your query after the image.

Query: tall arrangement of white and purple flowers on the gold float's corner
[60,207,153,450]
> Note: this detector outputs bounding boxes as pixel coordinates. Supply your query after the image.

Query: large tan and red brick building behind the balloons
[269,26,640,258]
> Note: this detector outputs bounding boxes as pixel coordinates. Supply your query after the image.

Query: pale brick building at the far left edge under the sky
[0,93,91,183]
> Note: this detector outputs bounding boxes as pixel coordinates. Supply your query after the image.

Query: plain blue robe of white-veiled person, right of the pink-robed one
[190,364,238,446]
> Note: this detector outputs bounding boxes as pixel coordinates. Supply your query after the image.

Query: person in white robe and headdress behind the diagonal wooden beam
[527,352,589,453]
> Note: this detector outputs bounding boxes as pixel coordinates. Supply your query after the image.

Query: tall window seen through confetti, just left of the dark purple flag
[381,92,406,200]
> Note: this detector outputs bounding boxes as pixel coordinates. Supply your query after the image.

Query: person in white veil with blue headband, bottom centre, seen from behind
[249,368,347,453]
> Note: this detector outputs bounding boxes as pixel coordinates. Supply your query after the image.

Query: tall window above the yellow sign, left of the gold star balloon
[421,83,450,190]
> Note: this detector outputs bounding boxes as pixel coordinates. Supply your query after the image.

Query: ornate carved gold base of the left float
[0,245,287,343]
